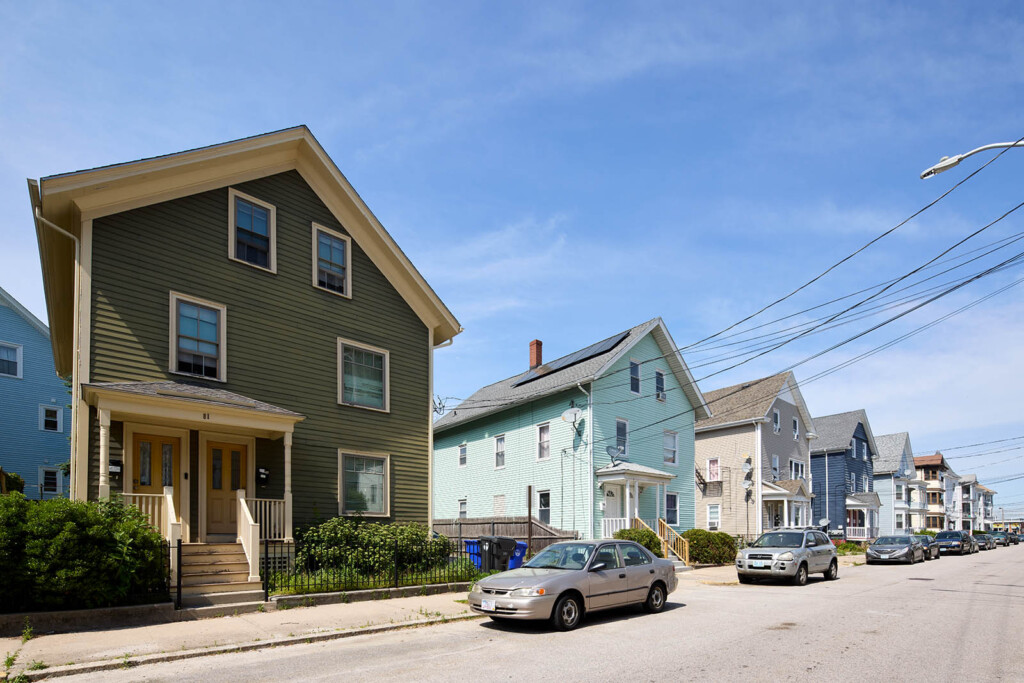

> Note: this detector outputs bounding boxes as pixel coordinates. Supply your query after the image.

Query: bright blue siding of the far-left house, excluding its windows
[0,302,71,499]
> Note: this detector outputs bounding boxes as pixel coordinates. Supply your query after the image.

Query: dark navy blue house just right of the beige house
[811,411,881,541]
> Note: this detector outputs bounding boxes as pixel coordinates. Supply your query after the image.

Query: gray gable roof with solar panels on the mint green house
[434,317,711,433]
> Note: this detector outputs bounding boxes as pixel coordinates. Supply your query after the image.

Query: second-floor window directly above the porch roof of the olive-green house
[171,292,227,382]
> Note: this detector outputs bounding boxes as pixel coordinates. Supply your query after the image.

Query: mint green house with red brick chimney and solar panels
[431,318,711,539]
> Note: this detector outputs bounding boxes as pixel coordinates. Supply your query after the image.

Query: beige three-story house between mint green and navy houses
[694,373,815,538]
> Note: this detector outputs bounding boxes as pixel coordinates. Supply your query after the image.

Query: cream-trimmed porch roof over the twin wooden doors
[82,382,305,438]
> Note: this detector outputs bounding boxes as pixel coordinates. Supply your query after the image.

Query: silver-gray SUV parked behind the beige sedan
[736,529,839,586]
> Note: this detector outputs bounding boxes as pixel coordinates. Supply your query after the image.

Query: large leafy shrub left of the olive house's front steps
[0,493,169,612]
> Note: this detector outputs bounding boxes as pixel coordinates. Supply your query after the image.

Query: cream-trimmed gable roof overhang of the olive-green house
[29,126,462,375]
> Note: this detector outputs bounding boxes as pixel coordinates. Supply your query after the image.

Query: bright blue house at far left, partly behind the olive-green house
[0,289,71,499]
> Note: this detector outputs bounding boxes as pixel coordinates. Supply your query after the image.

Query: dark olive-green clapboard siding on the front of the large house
[90,171,430,525]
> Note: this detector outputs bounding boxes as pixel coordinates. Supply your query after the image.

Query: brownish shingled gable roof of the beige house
[694,372,815,433]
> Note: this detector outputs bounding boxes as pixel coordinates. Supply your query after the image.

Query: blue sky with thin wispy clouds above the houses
[0,0,1024,507]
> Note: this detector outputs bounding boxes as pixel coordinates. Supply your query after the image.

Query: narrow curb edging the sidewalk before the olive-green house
[12,614,483,681]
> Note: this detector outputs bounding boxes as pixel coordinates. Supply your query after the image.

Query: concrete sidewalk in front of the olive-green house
[0,592,475,680]
